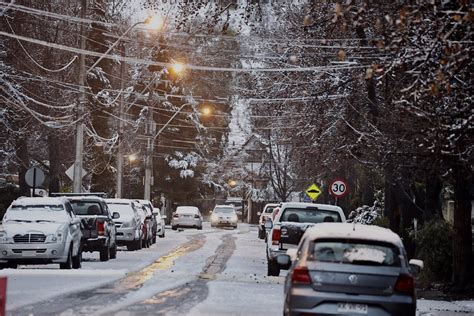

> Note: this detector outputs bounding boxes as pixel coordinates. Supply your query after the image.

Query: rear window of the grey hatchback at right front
[310,240,400,267]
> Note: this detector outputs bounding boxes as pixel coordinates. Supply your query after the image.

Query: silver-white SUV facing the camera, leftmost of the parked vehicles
[0,197,82,269]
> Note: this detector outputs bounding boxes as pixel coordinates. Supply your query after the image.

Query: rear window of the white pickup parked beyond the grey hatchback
[280,208,342,224]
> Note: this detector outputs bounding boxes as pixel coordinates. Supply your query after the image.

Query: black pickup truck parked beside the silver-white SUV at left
[51,193,120,261]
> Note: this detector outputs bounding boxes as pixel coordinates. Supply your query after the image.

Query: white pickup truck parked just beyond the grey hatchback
[267,202,346,276]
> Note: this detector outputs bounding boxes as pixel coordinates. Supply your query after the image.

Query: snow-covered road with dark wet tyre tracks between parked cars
[0,223,474,315]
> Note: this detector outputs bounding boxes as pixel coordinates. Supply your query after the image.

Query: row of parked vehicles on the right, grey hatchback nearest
[259,203,423,315]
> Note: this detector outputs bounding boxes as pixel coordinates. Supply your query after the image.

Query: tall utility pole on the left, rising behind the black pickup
[73,0,87,193]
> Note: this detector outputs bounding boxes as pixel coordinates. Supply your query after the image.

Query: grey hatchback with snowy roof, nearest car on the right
[278,223,423,316]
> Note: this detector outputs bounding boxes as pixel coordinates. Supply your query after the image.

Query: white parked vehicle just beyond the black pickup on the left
[105,199,145,250]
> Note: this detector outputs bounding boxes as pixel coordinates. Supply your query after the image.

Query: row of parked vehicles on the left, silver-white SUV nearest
[0,193,166,269]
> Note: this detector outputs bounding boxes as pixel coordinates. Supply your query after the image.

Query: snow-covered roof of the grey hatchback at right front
[303,223,402,247]
